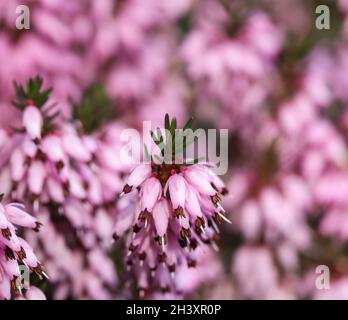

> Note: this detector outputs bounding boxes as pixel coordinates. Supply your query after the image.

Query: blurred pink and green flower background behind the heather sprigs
[0,0,348,299]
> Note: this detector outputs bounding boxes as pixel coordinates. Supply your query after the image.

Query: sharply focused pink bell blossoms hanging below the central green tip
[114,115,230,296]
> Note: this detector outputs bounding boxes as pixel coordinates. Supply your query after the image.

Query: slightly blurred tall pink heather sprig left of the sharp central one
[0,78,127,299]
